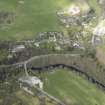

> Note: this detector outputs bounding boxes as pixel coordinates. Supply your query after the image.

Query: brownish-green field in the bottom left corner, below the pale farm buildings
[0,90,56,105]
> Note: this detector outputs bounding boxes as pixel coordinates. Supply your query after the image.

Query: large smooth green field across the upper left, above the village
[0,0,71,40]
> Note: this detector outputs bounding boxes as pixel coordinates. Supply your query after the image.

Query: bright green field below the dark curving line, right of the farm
[44,70,105,105]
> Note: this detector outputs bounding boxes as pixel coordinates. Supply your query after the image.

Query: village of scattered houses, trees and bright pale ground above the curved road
[0,2,105,65]
